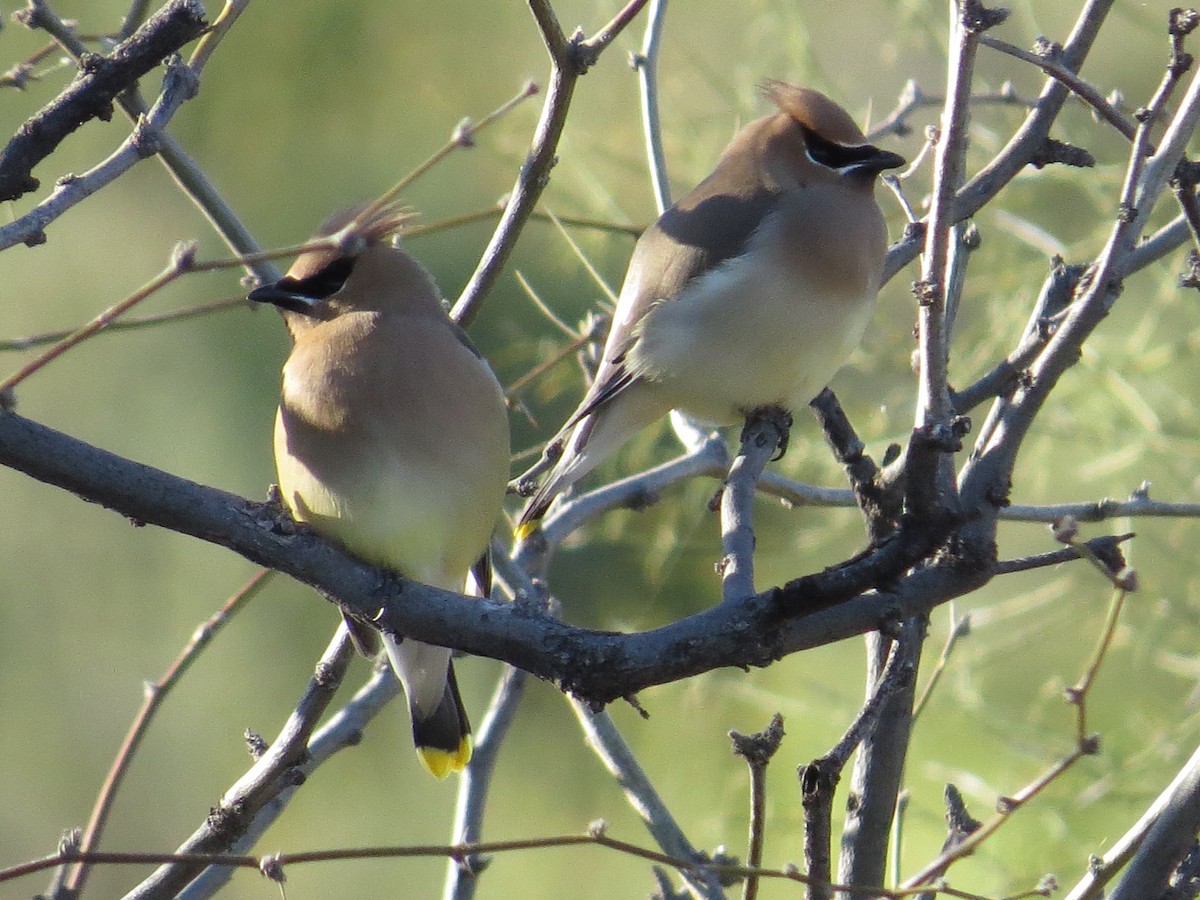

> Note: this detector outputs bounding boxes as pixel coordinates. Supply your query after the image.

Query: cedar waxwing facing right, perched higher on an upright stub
[517,82,904,539]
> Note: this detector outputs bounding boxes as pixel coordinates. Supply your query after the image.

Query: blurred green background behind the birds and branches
[0,0,1200,900]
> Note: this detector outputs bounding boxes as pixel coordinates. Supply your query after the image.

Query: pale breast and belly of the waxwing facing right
[628,186,887,424]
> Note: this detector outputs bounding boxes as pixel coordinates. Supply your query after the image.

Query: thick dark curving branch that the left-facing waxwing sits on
[0,413,974,702]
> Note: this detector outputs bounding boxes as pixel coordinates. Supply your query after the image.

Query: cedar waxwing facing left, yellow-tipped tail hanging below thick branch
[250,202,509,778]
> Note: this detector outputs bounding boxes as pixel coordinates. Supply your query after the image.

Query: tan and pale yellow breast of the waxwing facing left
[275,313,509,588]
